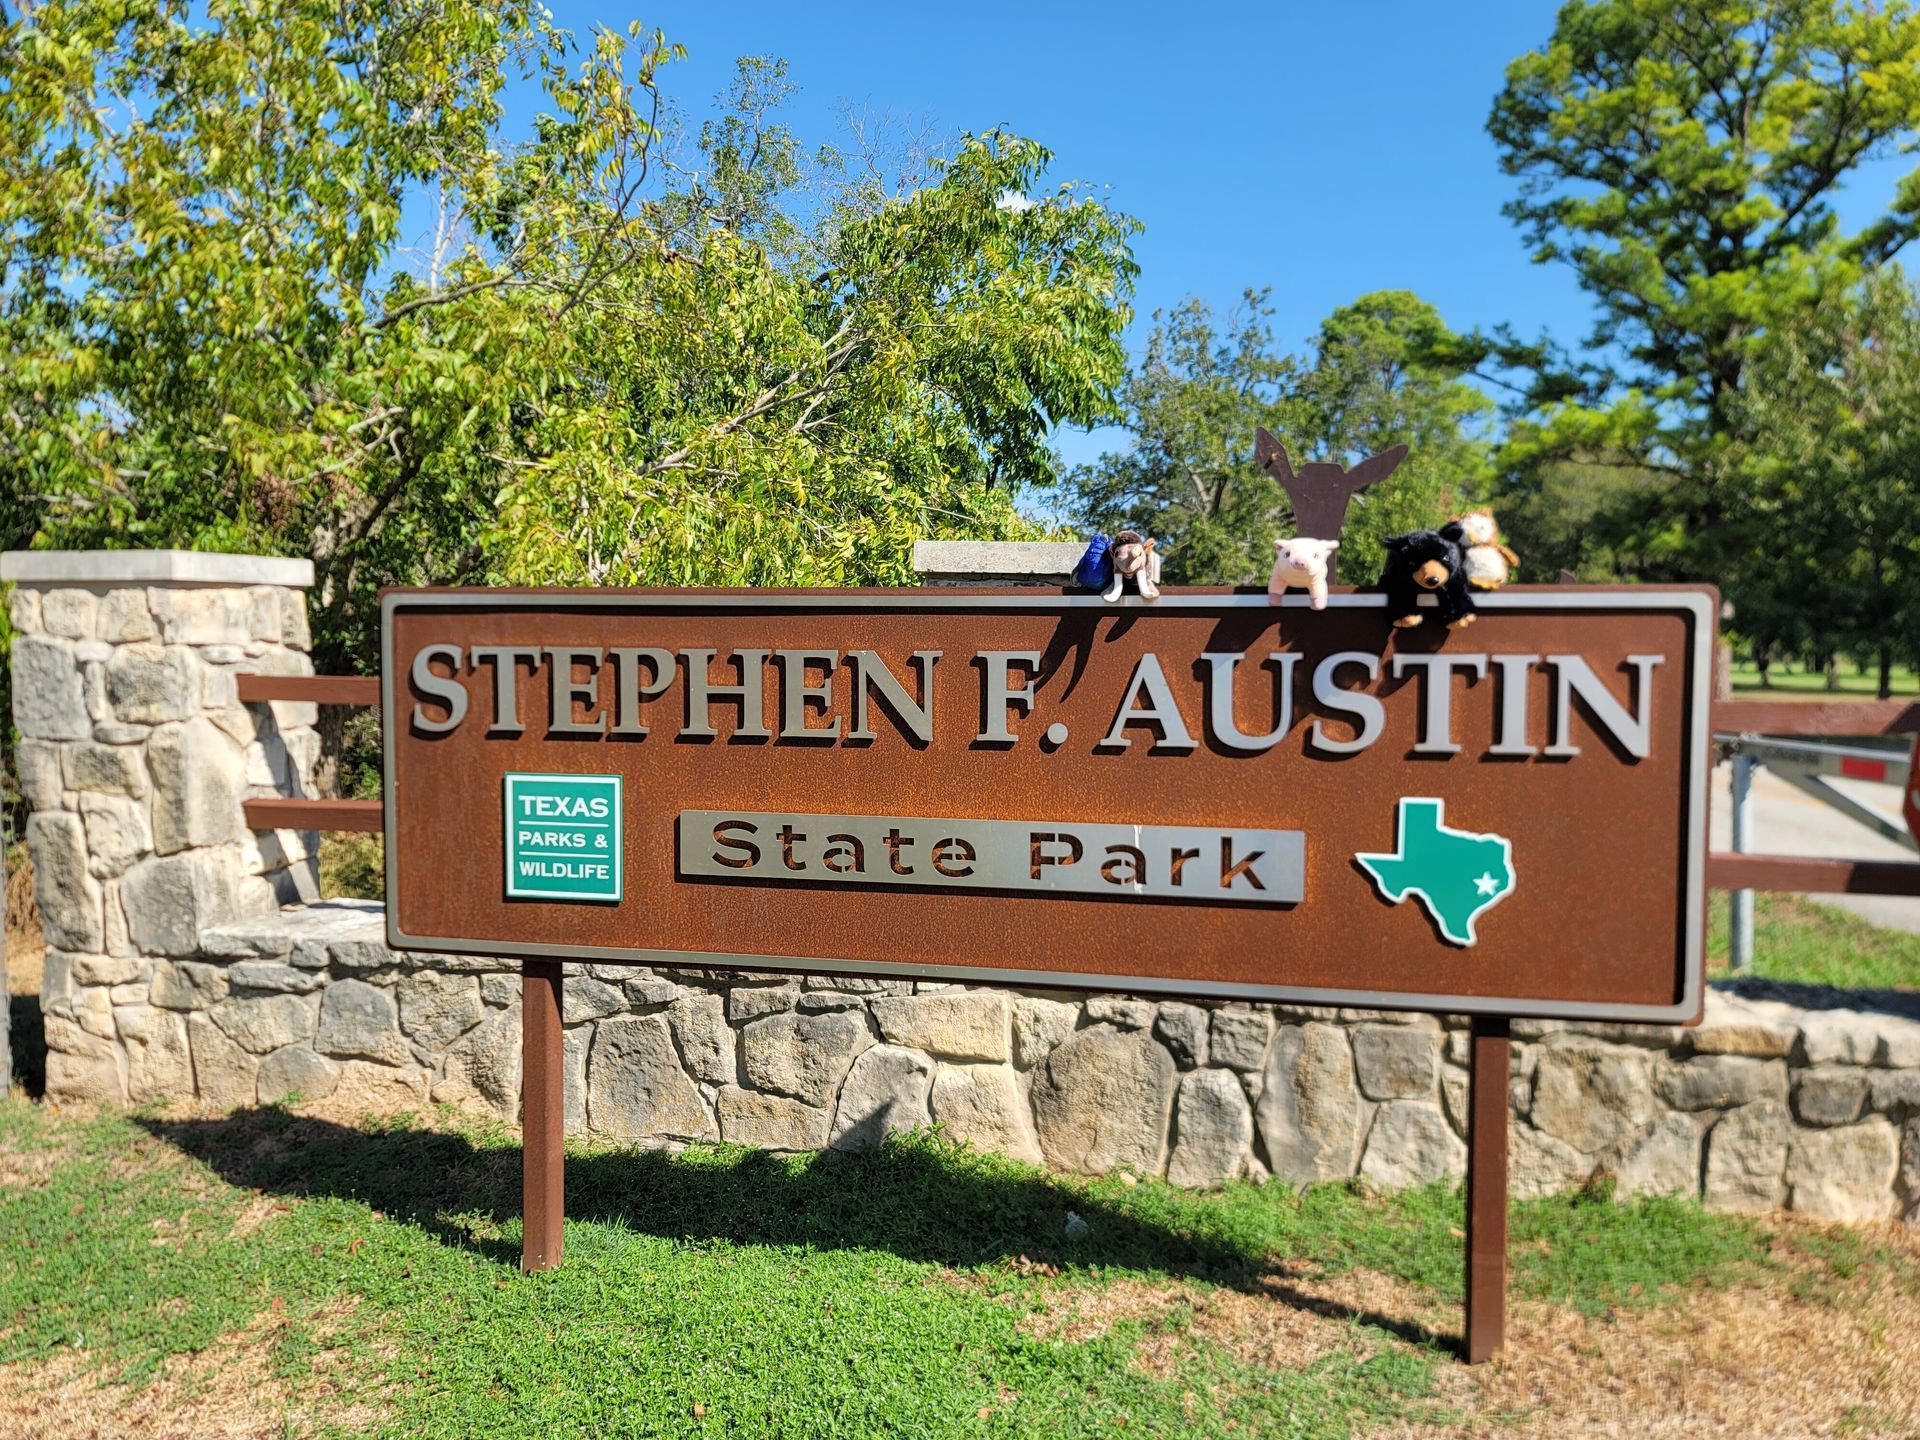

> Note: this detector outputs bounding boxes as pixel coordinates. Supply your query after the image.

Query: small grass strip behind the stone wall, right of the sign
[1707,891,1920,991]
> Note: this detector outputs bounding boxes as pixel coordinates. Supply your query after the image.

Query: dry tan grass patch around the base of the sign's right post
[1020,1215,1920,1440]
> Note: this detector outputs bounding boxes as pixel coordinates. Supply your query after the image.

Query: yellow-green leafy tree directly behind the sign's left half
[490,134,1133,586]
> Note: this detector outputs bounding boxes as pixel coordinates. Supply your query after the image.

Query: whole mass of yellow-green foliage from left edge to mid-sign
[0,0,1135,683]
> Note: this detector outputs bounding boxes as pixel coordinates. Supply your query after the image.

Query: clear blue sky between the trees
[509,0,1920,461]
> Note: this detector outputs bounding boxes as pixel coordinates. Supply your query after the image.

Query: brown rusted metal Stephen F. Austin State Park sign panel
[382,588,1716,1021]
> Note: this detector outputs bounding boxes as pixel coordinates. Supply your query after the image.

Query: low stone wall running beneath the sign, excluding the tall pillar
[30,902,1920,1221]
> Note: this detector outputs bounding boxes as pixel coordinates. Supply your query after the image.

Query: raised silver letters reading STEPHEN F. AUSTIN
[409,645,1665,760]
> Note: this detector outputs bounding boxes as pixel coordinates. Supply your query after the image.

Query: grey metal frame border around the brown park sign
[380,586,1718,1025]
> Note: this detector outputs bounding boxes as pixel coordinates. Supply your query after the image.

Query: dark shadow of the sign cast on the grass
[138,1110,1457,1350]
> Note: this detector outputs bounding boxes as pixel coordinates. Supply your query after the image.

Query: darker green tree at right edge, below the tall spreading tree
[1730,267,1920,699]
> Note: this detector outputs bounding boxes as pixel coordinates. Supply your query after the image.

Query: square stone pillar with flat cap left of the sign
[0,551,319,1100]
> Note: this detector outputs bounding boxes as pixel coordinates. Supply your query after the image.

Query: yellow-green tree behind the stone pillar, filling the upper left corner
[0,0,674,668]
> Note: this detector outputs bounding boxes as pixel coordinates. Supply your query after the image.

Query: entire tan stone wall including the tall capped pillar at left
[15,547,1920,1219]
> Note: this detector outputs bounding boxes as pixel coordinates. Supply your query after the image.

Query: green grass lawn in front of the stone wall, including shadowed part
[0,1100,1910,1440]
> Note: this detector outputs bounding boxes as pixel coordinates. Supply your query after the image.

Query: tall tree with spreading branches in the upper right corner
[1488,0,1920,574]
